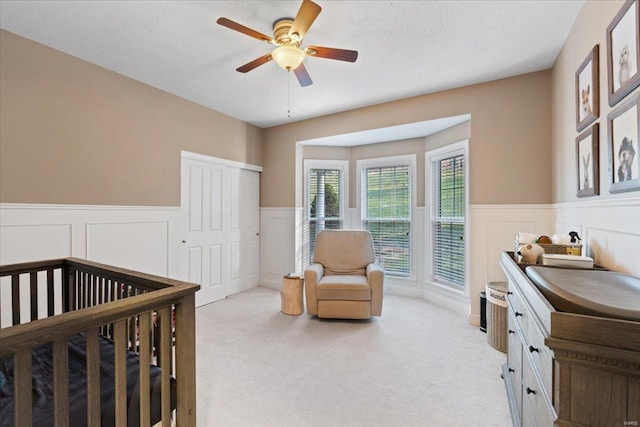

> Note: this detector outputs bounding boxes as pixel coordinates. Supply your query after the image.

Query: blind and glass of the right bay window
[432,154,466,287]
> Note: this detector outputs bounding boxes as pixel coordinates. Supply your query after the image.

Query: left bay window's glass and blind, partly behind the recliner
[307,169,344,262]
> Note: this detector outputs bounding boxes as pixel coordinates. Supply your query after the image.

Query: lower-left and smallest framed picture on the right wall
[576,123,600,197]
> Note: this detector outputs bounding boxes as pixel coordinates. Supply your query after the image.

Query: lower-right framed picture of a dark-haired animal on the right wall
[607,93,640,193]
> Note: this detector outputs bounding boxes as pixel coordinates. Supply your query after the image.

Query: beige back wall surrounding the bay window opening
[261,71,551,207]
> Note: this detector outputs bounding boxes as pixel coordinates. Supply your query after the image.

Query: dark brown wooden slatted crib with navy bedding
[0,258,199,426]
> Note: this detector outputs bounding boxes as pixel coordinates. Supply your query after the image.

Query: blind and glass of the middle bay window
[362,165,411,276]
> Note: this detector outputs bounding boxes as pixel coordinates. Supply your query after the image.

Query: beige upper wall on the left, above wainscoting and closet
[0,31,262,206]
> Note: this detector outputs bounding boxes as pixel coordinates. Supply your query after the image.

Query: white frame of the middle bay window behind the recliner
[356,154,417,280]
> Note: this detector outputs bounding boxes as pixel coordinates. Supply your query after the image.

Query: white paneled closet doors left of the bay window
[181,158,260,306]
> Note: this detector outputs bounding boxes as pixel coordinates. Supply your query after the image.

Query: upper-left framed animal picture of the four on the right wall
[576,45,600,132]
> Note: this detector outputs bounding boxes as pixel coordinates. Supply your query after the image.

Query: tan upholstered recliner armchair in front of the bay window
[304,230,384,319]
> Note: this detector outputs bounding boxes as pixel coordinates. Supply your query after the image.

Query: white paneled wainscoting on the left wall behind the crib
[0,204,180,278]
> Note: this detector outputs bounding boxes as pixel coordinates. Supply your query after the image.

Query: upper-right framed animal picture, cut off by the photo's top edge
[607,0,640,107]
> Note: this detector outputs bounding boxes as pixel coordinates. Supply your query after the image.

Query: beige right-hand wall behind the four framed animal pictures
[552,1,638,203]
